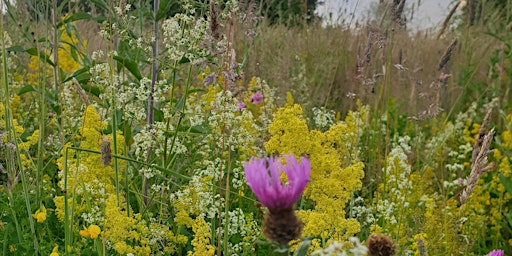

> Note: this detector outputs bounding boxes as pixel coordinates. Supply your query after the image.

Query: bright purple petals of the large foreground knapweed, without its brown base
[244,154,311,211]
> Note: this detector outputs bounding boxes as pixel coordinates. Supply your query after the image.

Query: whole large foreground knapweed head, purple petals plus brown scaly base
[244,154,311,244]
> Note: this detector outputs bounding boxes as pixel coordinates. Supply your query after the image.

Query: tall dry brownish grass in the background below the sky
[238,18,498,117]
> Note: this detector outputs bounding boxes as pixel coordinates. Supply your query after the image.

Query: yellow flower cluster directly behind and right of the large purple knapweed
[265,104,364,246]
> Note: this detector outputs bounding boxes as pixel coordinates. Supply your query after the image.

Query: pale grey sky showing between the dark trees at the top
[317,0,455,29]
